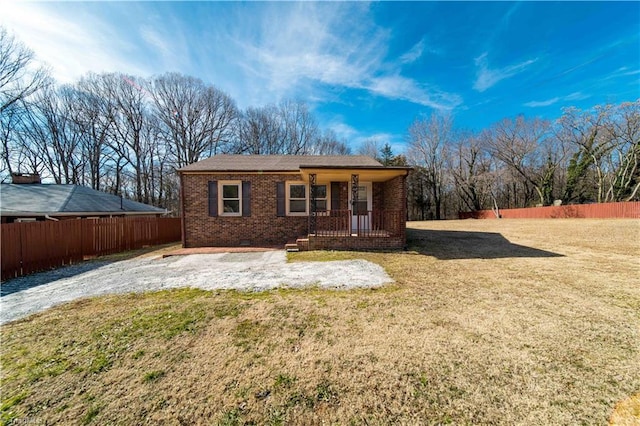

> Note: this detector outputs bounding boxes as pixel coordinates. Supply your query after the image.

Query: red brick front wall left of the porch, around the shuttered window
[183,174,308,247]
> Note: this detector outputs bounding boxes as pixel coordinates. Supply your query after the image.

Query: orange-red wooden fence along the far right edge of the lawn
[459,201,640,219]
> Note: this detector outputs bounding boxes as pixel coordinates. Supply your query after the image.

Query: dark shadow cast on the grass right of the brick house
[407,229,563,260]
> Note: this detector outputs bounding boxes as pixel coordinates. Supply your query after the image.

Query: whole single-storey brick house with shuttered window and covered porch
[178,155,411,250]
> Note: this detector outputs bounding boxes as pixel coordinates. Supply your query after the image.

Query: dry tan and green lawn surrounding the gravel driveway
[1,219,640,425]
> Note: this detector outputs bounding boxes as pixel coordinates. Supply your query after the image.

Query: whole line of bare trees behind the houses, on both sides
[0,27,640,219]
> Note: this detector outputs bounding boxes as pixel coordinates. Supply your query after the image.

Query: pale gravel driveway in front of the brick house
[0,251,393,324]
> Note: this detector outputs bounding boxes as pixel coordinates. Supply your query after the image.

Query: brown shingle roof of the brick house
[179,155,383,172]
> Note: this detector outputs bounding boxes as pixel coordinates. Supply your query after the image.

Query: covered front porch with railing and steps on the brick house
[299,167,410,250]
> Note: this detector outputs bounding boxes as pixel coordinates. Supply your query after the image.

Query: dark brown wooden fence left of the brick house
[0,217,181,281]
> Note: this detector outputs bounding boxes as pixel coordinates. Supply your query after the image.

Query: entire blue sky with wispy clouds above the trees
[0,2,640,152]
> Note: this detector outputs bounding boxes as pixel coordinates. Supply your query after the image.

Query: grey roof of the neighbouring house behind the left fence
[0,184,166,216]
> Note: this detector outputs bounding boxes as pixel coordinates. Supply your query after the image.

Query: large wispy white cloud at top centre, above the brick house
[225,3,461,109]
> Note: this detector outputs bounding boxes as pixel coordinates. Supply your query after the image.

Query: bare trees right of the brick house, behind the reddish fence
[402,100,640,219]
